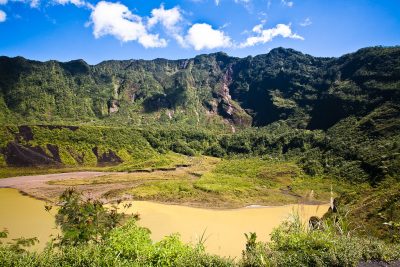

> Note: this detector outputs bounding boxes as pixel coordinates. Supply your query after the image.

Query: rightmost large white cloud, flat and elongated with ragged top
[239,24,304,48]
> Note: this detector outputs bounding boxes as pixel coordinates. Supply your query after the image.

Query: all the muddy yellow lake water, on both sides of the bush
[0,189,328,257]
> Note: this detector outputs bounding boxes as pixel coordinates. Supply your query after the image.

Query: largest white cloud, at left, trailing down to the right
[90,1,167,48]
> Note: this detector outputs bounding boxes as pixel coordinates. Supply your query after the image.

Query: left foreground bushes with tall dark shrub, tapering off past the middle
[0,189,233,267]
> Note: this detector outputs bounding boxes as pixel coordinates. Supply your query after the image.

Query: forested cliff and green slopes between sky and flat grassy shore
[0,47,400,244]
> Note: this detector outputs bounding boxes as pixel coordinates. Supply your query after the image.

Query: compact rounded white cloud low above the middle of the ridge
[185,23,232,50]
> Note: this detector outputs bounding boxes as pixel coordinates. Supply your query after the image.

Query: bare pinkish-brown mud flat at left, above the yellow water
[0,172,123,201]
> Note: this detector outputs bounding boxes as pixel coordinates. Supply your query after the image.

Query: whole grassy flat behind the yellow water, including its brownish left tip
[50,157,350,207]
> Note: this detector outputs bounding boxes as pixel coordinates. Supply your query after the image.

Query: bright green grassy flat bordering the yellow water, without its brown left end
[124,158,350,207]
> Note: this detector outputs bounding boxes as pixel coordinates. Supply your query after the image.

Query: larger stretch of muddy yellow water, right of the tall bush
[127,201,329,257]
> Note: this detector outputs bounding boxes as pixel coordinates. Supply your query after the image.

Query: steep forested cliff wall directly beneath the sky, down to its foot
[0,47,400,130]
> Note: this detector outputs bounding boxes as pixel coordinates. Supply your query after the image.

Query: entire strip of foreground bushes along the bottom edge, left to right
[0,189,400,267]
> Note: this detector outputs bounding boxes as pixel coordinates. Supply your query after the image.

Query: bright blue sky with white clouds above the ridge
[0,0,400,64]
